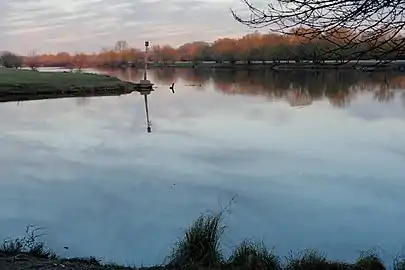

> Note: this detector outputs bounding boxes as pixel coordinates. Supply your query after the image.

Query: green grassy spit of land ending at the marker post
[0,68,134,102]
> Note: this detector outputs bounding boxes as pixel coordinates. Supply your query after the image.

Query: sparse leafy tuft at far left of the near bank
[0,226,56,259]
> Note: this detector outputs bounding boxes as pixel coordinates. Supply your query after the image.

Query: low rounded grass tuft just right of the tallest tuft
[229,240,282,270]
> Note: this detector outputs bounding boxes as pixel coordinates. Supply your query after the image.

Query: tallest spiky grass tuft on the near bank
[168,212,224,268]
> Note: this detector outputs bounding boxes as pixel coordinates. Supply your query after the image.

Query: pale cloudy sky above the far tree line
[0,0,264,53]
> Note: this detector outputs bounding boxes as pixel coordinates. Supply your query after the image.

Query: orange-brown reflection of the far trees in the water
[97,68,405,108]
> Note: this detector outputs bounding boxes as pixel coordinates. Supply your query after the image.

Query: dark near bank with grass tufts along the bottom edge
[0,214,405,270]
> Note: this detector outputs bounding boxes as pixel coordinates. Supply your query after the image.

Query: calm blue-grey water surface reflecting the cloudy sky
[0,70,405,265]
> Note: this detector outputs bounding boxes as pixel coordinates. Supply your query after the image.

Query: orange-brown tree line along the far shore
[3,28,405,69]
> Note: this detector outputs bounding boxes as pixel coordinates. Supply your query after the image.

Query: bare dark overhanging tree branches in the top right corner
[232,0,405,62]
